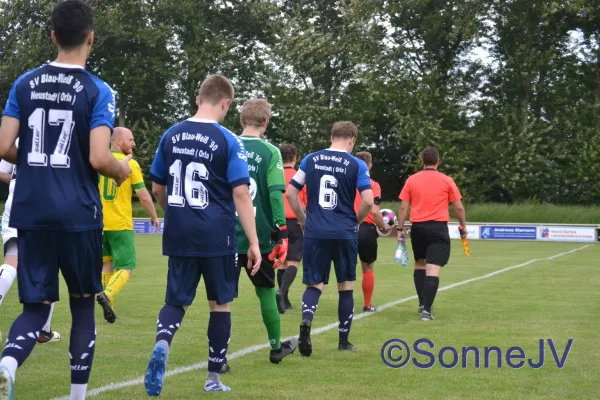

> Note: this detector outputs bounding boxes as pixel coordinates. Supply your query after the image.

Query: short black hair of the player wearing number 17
[52,0,94,51]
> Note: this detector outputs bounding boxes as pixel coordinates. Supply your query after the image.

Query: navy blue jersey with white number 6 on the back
[290,149,371,239]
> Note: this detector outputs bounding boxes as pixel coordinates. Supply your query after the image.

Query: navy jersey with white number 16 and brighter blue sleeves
[150,118,250,257]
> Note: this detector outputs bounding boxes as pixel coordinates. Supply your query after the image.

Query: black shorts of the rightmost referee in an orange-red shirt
[410,221,450,267]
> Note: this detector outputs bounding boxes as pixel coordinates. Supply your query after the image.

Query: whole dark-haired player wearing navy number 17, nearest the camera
[0,0,131,400]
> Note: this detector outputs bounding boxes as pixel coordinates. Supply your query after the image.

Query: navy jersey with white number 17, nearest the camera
[3,62,115,232]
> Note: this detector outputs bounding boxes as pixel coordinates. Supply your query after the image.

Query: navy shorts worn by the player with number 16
[165,254,238,306]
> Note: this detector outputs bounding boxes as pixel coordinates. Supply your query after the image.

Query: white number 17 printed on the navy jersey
[27,108,75,168]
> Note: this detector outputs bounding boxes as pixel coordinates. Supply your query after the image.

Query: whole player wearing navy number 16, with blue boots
[144,75,261,396]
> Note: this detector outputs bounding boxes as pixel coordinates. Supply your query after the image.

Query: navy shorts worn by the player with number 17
[17,229,102,303]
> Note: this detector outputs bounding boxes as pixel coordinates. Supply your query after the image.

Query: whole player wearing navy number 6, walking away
[286,122,373,357]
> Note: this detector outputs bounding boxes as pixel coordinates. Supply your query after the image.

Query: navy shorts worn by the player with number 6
[302,237,358,285]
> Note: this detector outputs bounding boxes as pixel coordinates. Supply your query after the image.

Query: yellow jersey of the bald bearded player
[99,151,145,231]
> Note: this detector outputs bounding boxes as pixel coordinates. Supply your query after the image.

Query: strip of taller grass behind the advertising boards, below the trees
[381,202,600,224]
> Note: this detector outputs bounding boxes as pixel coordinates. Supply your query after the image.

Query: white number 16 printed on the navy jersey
[167,160,209,210]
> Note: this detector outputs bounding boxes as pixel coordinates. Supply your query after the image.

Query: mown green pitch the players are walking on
[0,236,600,400]
